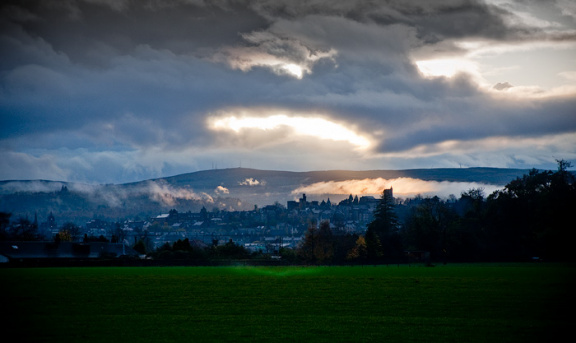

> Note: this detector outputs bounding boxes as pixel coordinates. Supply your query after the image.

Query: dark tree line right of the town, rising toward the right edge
[284,160,576,264]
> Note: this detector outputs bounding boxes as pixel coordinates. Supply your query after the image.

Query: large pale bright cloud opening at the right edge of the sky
[413,38,576,100]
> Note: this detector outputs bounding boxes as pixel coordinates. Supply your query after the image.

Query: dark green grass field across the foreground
[0,264,576,342]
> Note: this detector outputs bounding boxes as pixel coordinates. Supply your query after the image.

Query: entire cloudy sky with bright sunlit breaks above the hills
[0,0,576,183]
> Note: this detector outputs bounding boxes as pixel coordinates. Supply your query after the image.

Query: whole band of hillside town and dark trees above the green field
[0,161,576,264]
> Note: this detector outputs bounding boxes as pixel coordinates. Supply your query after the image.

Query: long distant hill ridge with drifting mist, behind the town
[0,168,528,222]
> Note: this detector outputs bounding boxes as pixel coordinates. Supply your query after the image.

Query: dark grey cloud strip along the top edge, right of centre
[253,0,535,44]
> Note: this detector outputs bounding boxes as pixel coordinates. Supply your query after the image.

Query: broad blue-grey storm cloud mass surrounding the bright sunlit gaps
[0,0,576,180]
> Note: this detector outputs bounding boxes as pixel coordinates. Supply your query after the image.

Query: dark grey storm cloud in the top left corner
[1,1,265,65]
